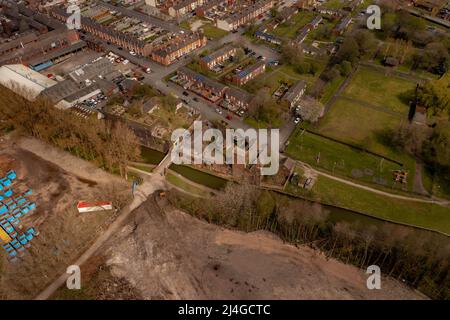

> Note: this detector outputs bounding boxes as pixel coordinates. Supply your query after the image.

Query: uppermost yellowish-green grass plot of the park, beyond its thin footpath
[343,67,416,114]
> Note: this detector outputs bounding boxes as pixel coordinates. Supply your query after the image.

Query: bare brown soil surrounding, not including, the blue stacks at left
[0,138,130,299]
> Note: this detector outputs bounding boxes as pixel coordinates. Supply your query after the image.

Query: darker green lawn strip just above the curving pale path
[286,128,408,187]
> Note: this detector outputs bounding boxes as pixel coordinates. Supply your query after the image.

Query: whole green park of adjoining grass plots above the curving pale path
[287,67,422,192]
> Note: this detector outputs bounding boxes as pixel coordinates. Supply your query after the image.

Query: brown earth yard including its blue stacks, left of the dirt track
[0,137,131,299]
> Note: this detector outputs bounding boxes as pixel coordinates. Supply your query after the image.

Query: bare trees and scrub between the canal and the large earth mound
[167,183,450,299]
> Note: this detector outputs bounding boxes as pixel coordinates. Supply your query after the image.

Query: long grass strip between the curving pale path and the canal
[286,176,450,234]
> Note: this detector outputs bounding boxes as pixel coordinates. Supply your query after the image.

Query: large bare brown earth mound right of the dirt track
[53,199,424,299]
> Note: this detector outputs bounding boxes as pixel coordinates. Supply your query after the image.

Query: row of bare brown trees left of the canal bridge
[0,86,140,176]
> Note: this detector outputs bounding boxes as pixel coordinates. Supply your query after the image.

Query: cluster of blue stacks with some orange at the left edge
[0,171,38,261]
